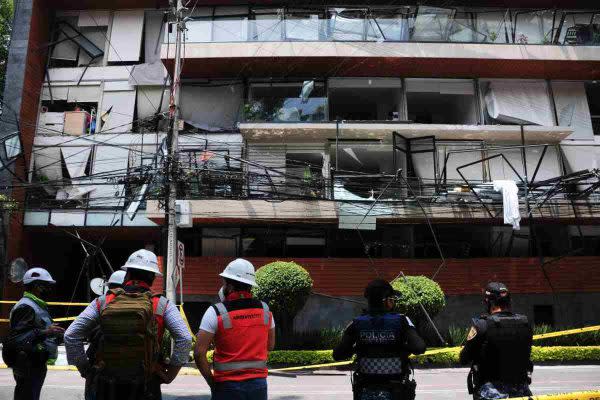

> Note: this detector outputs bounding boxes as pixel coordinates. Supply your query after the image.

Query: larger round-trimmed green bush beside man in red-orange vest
[253,261,313,332]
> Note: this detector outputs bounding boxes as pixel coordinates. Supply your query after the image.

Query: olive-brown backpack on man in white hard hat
[96,289,160,381]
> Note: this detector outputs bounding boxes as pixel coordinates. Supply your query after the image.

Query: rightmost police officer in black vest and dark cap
[460,282,533,400]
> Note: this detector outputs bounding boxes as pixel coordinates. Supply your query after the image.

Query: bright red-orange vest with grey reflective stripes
[212,298,272,382]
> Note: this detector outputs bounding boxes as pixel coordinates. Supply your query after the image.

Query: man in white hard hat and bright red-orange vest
[194,258,275,400]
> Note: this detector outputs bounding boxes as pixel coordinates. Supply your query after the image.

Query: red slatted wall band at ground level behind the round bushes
[154,257,600,296]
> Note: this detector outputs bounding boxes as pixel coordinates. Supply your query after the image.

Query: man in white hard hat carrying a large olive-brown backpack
[65,249,192,400]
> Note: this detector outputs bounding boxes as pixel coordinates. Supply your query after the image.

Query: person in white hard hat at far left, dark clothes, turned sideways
[3,268,65,400]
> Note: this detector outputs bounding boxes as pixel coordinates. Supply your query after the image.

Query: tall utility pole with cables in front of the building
[165,0,184,304]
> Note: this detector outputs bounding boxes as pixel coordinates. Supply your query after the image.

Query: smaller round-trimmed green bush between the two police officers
[392,276,446,327]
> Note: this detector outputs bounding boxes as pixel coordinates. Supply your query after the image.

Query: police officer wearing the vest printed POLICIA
[333,279,425,400]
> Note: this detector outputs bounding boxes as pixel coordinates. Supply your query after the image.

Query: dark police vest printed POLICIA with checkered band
[354,313,408,378]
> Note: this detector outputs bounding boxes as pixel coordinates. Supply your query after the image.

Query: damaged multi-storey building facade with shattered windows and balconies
[0,0,600,330]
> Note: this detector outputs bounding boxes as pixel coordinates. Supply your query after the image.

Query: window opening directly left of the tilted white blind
[406,79,478,125]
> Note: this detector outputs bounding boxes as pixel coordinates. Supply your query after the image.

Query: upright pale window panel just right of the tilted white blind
[552,81,594,139]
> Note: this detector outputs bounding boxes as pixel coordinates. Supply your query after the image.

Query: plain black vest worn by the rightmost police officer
[479,313,532,384]
